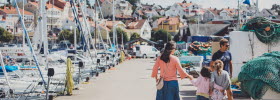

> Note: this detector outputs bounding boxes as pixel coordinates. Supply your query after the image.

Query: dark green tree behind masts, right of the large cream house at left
[58,29,81,43]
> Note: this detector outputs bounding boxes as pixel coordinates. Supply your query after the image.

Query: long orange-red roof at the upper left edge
[0,7,33,15]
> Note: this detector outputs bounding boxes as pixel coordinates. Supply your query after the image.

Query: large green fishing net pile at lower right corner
[238,51,280,99]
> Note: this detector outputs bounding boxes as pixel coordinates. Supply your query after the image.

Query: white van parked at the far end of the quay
[136,45,160,58]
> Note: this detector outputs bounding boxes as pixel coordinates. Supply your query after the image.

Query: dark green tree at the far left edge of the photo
[0,27,14,42]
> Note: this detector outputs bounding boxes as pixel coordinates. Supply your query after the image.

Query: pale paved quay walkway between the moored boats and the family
[56,59,196,100]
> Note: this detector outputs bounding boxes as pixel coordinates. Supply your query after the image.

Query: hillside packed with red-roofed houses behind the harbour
[0,0,280,42]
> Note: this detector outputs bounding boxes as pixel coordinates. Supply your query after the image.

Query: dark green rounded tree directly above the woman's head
[154,29,171,43]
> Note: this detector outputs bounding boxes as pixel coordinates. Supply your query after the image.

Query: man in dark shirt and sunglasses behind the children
[210,39,232,77]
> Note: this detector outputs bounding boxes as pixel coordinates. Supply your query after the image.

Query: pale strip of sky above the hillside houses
[141,0,280,10]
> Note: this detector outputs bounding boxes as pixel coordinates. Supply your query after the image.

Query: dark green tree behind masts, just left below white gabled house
[109,28,129,44]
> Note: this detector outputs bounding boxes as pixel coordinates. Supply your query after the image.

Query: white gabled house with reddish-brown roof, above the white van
[125,19,152,39]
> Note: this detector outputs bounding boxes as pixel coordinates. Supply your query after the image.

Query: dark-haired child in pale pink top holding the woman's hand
[189,67,221,100]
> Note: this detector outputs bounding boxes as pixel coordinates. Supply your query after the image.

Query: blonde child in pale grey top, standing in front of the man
[211,60,232,100]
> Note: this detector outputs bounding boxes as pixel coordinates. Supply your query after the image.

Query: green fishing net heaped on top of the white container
[241,17,280,43]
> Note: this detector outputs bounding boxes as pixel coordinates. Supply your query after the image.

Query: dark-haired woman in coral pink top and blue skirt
[152,41,189,100]
